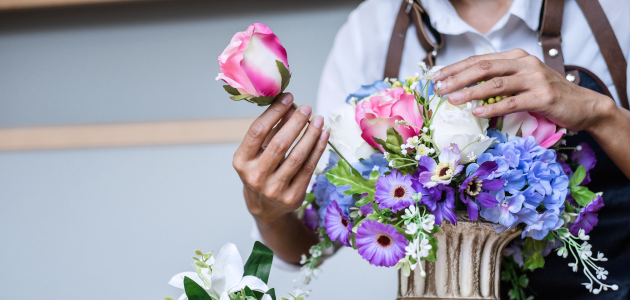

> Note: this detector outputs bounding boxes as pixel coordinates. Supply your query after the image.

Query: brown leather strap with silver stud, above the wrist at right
[538,0,565,76]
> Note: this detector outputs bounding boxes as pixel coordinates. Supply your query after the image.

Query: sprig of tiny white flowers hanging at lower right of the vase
[557,228,619,294]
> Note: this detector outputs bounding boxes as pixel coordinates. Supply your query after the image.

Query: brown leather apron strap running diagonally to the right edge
[577,0,630,109]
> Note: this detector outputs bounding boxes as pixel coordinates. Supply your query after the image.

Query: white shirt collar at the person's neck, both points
[421,0,542,35]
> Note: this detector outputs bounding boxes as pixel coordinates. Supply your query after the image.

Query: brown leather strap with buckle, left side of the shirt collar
[384,0,444,78]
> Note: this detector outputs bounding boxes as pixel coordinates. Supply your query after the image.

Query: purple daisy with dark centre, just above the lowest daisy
[374,171,416,213]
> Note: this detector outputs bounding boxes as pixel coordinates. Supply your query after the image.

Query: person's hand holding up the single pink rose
[232,94,330,226]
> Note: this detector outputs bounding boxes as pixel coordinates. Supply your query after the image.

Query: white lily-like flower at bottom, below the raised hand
[168,243,271,300]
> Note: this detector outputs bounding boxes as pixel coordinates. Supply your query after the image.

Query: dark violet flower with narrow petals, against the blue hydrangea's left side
[459,161,505,220]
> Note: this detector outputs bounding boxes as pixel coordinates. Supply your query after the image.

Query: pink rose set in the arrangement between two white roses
[355,87,422,151]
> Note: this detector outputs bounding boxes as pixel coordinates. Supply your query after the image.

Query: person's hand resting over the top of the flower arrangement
[435,49,614,131]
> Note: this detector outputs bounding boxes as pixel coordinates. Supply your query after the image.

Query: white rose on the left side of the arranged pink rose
[329,103,377,163]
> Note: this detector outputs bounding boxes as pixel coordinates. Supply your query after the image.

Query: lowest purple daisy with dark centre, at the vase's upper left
[356,219,409,267]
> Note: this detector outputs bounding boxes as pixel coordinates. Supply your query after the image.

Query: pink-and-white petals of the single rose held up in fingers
[216,23,289,97]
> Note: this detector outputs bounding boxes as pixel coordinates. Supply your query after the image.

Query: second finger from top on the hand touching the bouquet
[439,59,524,95]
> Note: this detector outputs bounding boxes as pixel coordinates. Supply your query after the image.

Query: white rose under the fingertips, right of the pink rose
[430,98,494,163]
